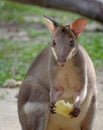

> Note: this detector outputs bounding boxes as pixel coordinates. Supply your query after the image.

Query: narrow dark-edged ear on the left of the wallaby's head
[44,16,58,33]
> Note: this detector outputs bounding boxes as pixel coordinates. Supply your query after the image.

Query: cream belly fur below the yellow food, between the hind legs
[47,89,92,130]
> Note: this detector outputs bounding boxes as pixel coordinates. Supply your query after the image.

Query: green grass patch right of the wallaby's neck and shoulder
[79,32,103,67]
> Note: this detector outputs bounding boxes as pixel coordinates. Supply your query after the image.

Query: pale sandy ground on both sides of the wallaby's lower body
[0,69,103,130]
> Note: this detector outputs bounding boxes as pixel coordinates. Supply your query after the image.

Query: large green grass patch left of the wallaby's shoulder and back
[0,39,46,84]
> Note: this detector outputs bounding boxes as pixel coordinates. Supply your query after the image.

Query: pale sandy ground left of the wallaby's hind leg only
[0,89,20,130]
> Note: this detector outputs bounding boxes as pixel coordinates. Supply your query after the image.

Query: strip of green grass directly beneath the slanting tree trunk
[0,1,79,24]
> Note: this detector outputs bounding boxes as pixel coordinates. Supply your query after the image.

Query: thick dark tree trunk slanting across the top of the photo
[10,0,103,24]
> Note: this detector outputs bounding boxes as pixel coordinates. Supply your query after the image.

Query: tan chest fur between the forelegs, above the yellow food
[54,61,81,100]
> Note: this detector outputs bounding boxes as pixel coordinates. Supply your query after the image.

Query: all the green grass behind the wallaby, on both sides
[0,1,103,85]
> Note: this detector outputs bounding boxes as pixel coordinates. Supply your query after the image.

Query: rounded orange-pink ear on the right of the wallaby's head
[70,18,87,36]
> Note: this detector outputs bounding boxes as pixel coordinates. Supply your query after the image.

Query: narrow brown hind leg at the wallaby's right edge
[81,96,96,130]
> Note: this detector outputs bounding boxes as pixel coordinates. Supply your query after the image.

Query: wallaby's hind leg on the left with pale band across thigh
[18,85,49,130]
